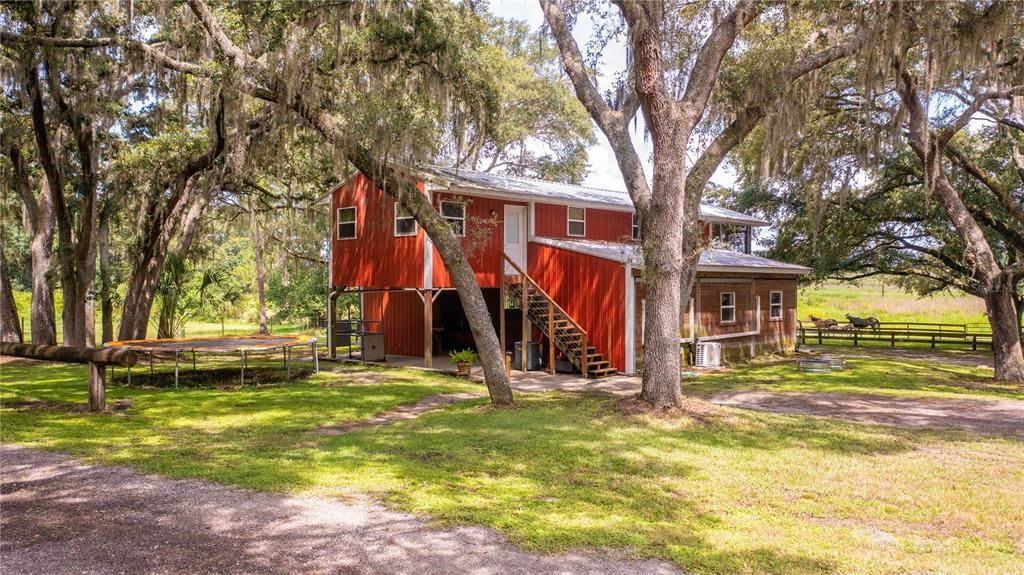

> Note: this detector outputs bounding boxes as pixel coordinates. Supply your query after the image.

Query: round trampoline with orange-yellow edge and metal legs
[103,336,319,389]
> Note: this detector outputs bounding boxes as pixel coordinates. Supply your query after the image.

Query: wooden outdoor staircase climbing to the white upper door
[502,255,616,378]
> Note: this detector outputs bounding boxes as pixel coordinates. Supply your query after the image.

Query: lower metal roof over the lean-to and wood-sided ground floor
[529,237,811,275]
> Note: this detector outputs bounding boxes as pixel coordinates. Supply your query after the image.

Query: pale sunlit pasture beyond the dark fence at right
[797,283,988,325]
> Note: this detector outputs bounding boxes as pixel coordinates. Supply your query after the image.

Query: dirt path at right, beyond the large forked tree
[711,391,1024,438]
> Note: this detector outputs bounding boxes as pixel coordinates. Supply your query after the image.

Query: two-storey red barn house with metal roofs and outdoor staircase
[329,167,810,375]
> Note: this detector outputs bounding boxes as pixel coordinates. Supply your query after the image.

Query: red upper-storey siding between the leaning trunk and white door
[433,193,528,288]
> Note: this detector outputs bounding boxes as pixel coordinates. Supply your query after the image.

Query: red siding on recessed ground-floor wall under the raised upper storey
[362,292,423,356]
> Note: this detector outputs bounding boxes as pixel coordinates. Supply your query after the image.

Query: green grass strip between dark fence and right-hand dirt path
[683,346,1024,400]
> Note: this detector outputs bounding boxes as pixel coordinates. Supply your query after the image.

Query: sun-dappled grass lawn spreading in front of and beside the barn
[0,359,1024,574]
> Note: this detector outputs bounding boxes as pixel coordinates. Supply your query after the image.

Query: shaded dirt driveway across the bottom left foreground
[0,446,680,575]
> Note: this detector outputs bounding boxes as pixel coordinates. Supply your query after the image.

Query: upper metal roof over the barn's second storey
[419,166,769,226]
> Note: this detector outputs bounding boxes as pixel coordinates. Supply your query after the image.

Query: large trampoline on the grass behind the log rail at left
[103,336,319,388]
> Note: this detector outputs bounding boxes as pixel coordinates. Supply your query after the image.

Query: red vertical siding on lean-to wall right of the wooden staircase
[526,242,626,370]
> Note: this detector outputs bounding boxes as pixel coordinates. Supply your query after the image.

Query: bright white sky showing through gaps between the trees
[490,0,735,190]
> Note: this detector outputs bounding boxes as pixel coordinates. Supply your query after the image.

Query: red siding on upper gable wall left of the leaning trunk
[331,169,424,288]
